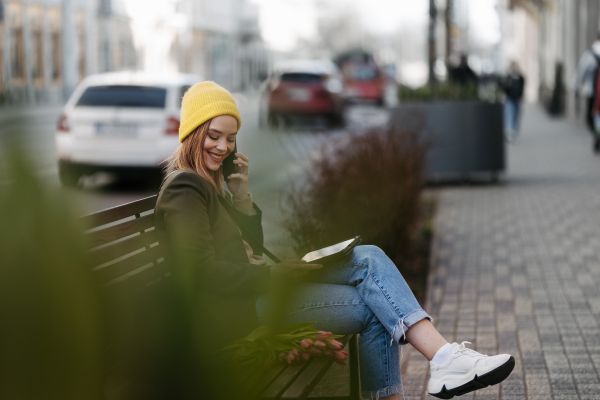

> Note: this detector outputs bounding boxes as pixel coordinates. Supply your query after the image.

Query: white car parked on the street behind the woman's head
[55,72,202,186]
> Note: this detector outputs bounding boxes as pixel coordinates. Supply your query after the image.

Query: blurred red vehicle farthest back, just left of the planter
[342,60,386,105]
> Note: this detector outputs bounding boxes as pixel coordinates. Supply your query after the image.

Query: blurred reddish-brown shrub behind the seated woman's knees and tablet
[284,129,426,258]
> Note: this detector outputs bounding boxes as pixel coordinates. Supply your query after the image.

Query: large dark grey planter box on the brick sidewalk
[391,101,505,180]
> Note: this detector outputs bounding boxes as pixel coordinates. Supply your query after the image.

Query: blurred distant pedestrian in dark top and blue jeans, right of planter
[502,61,525,142]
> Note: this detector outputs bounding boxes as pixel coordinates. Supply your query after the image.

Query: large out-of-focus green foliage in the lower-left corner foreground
[0,151,105,400]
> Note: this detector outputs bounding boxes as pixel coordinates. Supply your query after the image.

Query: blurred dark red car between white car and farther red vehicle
[266,60,345,125]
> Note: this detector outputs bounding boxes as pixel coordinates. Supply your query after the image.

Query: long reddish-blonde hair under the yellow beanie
[165,119,225,195]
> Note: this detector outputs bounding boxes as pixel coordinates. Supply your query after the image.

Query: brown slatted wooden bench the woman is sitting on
[81,195,359,400]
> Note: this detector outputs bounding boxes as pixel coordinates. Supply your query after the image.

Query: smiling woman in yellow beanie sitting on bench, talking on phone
[155,82,514,399]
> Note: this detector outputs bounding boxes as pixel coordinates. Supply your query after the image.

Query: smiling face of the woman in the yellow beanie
[202,115,237,172]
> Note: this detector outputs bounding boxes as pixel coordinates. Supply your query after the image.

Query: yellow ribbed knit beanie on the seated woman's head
[179,81,242,142]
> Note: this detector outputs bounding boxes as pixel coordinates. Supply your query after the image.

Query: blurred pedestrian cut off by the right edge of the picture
[575,32,600,136]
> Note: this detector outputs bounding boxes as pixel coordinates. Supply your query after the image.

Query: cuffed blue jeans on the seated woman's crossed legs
[256,246,431,398]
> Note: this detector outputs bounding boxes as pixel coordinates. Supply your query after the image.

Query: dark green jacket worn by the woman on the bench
[155,170,271,345]
